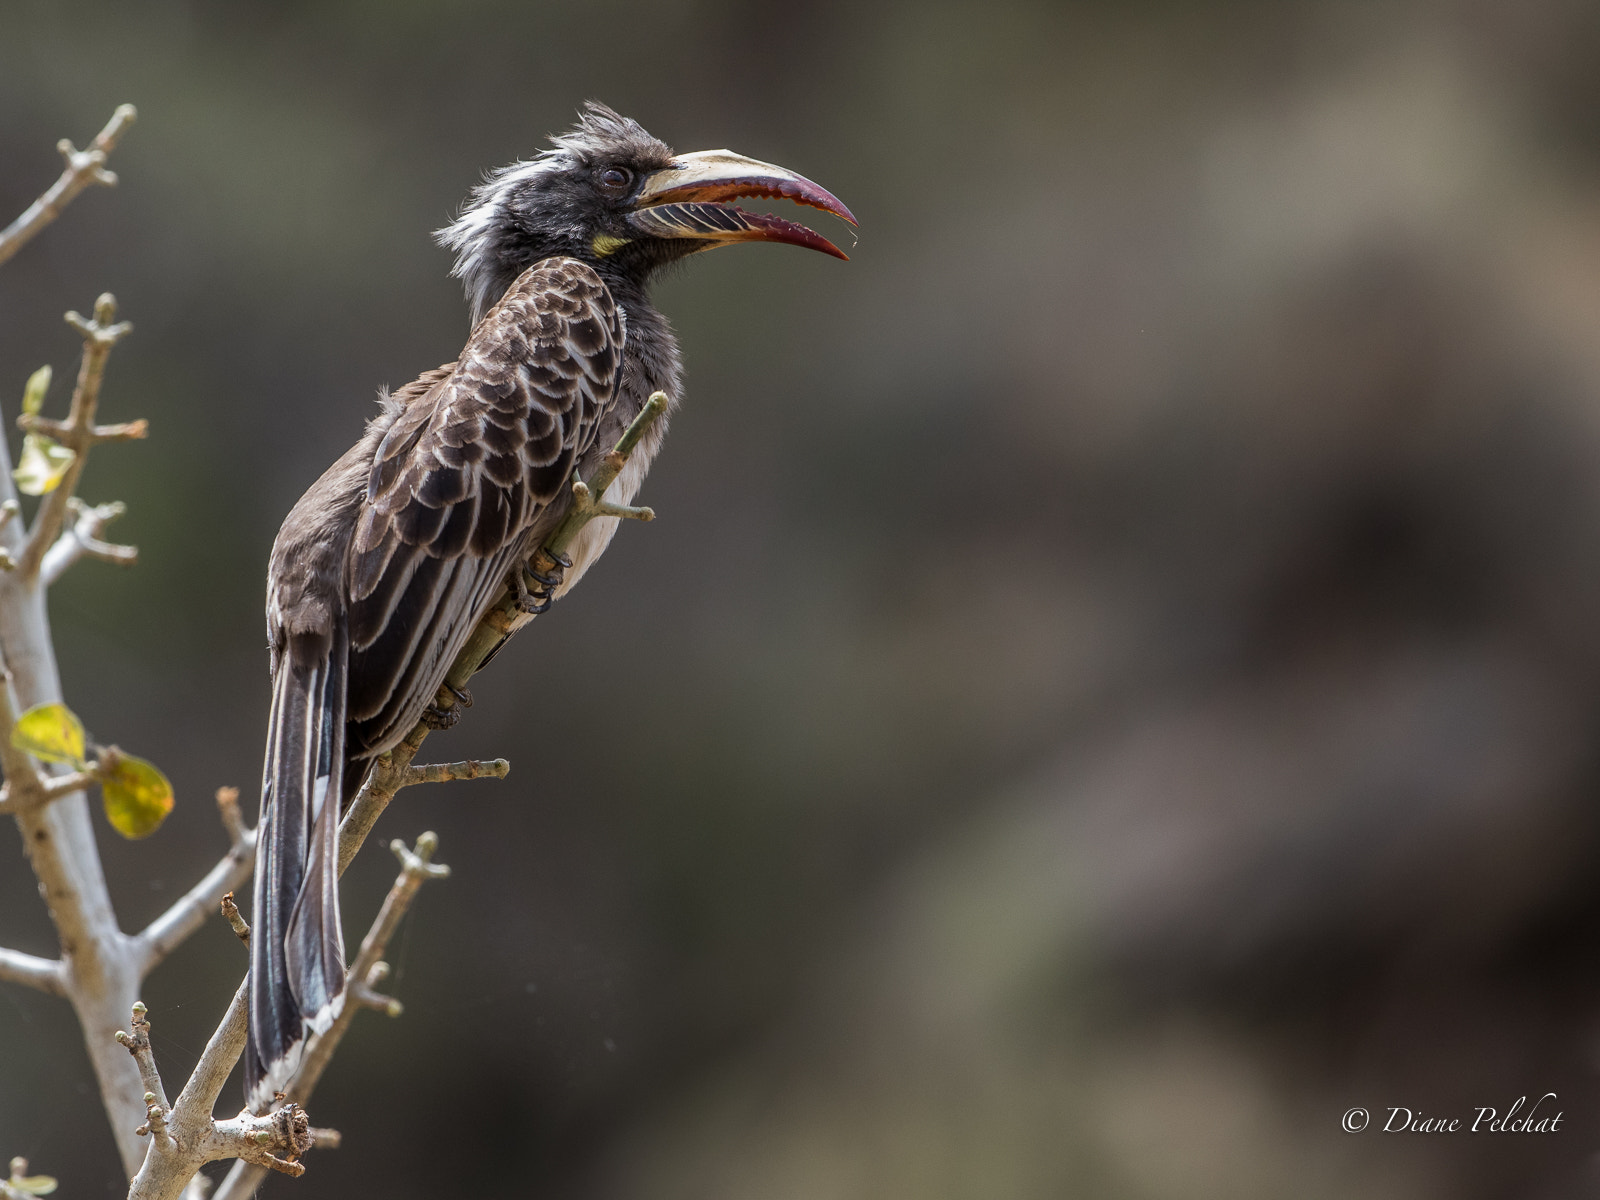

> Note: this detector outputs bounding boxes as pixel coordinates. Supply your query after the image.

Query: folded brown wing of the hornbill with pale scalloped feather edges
[346,259,622,757]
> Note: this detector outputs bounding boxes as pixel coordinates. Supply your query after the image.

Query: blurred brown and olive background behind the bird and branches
[0,0,1600,1200]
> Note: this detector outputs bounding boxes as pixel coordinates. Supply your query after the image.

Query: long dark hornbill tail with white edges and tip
[245,618,349,1112]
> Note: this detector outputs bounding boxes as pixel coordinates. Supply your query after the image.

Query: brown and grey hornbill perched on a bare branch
[245,101,856,1112]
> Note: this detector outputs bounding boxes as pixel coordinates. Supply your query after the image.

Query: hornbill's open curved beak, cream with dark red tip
[627,150,856,259]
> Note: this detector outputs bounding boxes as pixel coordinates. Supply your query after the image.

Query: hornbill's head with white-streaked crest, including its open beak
[435,101,856,322]
